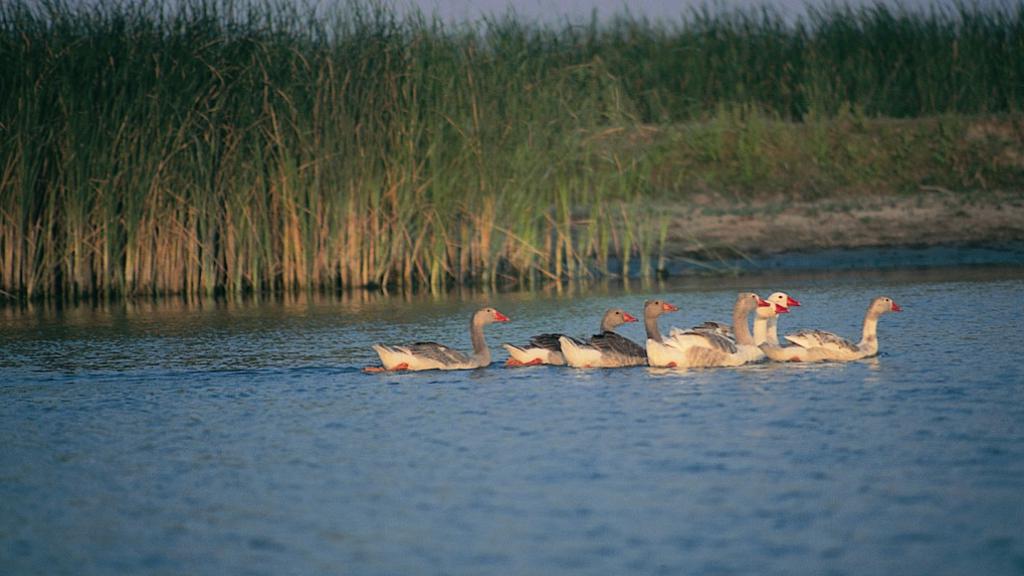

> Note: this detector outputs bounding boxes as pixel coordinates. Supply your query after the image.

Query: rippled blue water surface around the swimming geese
[0,269,1024,575]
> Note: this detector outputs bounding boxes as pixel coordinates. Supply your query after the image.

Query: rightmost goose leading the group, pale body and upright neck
[763,296,903,362]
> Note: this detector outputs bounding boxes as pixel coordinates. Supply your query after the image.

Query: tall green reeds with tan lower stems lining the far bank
[0,0,1024,297]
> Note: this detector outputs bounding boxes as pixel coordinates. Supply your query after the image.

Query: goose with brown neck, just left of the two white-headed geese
[647,292,772,368]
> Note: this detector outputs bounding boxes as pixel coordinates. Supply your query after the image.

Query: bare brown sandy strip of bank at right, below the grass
[664,191,1024,273]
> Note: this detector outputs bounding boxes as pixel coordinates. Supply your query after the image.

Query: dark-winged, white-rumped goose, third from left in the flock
[558,300,679,368]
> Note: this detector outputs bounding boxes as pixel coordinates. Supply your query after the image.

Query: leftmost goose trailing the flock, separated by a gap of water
[366,307,509,372]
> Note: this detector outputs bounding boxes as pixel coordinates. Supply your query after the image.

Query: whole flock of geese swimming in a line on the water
[366,292,900,372]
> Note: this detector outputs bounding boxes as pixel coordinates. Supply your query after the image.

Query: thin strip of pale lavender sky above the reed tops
[396,0,999,23]
